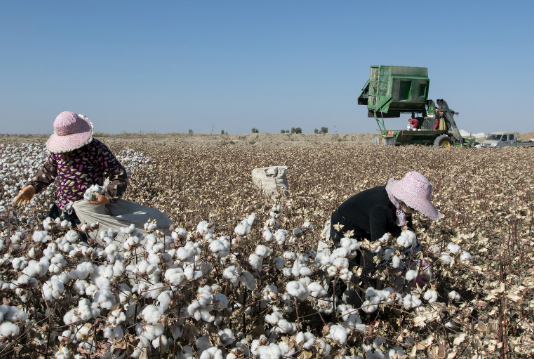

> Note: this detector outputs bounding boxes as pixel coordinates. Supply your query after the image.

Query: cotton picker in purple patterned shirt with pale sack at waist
[15,111,172,242]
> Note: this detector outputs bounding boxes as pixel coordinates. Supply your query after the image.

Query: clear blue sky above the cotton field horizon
[0,0,534,134]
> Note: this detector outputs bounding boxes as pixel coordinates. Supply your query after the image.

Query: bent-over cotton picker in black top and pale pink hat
[330,172,441,246]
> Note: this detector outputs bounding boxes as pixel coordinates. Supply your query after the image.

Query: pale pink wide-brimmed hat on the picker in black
[388,172,441,219]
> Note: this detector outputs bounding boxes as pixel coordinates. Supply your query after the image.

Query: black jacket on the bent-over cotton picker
[331,186,411,241]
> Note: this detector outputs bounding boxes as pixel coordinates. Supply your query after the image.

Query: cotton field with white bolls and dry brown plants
[0,138,534,359]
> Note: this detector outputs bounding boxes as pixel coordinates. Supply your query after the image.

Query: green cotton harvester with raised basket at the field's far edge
[358,65,475,147]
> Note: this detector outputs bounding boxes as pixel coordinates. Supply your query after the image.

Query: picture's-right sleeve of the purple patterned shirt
[95,141,128,202]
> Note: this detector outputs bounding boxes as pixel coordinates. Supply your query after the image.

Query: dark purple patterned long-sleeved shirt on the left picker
[28,139,128,209]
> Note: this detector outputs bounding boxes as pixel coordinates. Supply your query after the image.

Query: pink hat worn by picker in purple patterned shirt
[46,111,93,153]
